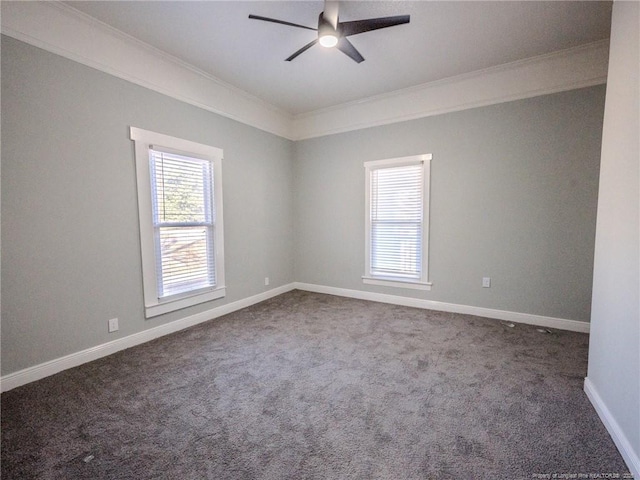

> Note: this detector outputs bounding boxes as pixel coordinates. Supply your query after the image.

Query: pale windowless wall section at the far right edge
[588,2,640,477]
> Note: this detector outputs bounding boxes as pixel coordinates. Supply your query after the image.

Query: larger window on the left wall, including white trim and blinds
[131,127,225,318]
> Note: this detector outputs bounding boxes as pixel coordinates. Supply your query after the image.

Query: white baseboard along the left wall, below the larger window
[0,284,294,392]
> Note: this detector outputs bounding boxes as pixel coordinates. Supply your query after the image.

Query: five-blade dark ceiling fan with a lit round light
[249,0,409,63]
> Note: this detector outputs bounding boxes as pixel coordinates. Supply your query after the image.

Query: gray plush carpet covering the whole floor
[2,291,630,480]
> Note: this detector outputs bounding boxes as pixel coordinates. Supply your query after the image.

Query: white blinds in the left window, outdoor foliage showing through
[149,149,216,298]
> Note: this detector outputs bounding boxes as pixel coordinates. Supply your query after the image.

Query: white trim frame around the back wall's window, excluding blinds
[362,153,433,290]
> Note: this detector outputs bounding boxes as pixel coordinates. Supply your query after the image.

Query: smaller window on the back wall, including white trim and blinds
[362,154,431,290]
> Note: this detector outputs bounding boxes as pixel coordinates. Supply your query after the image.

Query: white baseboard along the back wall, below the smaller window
[294,282,589,333]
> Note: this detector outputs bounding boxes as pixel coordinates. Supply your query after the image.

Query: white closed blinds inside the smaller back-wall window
[371,164,424,280]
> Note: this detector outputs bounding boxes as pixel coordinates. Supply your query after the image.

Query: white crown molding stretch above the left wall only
[2,1,292,138]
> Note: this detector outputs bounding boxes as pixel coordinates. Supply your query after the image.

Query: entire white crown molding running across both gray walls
[1,1,609,140]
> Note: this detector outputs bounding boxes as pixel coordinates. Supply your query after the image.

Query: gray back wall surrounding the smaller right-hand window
[294,86,605,322]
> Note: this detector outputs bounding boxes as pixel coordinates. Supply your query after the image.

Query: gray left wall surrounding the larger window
[1,37,294,374]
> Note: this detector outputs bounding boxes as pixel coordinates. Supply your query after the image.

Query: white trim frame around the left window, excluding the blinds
[130,127,226,318]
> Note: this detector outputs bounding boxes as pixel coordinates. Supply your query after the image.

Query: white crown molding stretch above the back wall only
[293,40,609,140]
